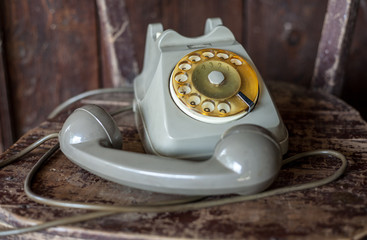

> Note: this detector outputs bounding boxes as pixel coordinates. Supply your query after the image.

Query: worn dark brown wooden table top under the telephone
[0,83,367,239]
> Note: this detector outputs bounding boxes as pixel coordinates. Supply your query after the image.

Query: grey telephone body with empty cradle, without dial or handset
[134,18,288,160]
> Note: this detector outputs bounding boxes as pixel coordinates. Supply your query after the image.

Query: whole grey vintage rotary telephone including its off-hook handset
[59,18,288,195]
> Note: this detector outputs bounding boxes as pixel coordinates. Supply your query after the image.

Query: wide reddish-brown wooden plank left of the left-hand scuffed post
[1,0,100,137]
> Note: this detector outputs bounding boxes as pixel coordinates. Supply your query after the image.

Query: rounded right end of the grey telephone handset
[213,124,282,178]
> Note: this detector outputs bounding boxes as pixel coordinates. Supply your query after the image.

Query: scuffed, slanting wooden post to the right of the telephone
[311,0,359,95]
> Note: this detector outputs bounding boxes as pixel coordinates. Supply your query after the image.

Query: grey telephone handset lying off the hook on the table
[59,105,281,195]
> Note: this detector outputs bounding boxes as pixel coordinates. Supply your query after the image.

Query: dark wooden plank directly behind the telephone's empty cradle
[126,0,246,69]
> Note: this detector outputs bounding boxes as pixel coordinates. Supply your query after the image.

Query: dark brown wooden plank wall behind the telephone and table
[0,0,367,152]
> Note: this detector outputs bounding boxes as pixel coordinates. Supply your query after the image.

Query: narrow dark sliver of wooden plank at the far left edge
[0,15,14,153]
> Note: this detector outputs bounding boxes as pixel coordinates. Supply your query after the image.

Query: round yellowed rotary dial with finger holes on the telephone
[170,49,259,123]
